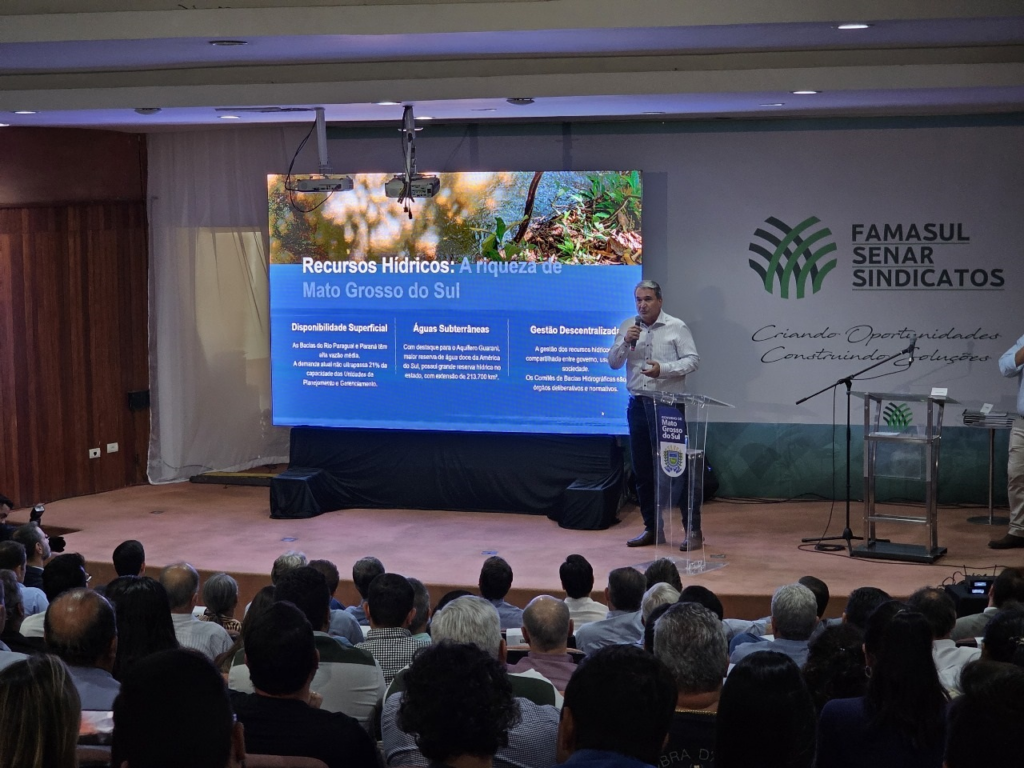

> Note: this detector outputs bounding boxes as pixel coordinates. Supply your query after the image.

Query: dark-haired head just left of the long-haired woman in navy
[803,624,867,713]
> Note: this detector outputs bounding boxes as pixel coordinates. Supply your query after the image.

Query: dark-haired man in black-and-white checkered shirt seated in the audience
[355,573,429,685]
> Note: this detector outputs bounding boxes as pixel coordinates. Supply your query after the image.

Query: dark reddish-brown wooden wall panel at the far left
[0,202,148,504]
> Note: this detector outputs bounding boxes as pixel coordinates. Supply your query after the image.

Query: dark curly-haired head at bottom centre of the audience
[398,643,519,765]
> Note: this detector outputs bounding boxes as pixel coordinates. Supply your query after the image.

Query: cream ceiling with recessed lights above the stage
[0,0,1024,131]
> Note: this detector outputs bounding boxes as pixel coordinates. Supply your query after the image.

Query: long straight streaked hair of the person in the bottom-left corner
[0,654,82,768]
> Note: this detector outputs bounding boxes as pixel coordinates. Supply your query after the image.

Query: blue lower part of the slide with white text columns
[270,260,641,434]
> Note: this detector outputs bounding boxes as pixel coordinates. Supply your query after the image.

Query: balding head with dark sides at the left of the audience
[43,589,118,671]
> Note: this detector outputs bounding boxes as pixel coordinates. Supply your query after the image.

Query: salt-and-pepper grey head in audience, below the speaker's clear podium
[654,603,729,695]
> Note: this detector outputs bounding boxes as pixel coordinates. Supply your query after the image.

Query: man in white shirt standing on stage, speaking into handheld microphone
[608,280,703,552]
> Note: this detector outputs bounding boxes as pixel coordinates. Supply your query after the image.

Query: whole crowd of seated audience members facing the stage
[0,523,1024,768]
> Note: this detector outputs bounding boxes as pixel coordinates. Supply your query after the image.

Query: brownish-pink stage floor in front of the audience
[28,483,1024,617]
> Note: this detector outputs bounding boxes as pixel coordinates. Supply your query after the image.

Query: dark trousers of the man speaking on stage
[626,397,703,535]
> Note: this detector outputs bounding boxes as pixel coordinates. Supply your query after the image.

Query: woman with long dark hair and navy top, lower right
[815,601,949,768]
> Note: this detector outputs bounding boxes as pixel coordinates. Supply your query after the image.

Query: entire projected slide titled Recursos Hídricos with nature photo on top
[268,171,642,434]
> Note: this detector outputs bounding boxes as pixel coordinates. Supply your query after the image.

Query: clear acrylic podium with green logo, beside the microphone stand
[851,392,957,563]
